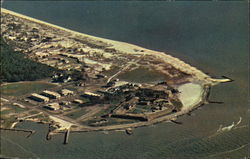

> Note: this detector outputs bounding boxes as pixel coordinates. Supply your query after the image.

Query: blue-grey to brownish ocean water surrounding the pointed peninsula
[1,1,249,159]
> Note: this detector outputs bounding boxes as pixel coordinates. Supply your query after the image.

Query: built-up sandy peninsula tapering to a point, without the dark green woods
[1,8,231,139]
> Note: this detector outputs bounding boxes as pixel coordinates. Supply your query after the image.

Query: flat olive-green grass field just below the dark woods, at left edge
[1,82,56,96]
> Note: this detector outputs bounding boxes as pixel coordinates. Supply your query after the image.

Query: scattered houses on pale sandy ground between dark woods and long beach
[1,13,118,83]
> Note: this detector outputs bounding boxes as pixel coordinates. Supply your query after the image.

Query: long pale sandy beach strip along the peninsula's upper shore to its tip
[1,8,231,85]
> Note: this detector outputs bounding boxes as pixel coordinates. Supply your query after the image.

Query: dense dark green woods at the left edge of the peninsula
[0,38,59,82]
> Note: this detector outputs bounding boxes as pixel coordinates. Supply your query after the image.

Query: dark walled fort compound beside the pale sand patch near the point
[96,81,181,121]
